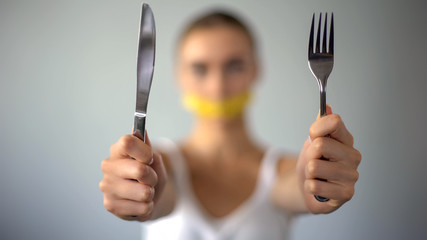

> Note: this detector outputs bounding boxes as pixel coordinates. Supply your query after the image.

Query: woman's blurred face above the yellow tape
[177,26,257,101]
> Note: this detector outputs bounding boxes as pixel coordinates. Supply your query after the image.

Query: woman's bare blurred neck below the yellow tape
[186,116,256,156]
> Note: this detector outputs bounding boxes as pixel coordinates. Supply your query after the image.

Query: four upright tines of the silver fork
[308,13,334,55]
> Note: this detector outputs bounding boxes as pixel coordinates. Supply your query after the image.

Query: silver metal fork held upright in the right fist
[308,13,334,202]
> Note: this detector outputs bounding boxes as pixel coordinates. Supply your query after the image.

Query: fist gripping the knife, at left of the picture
[99,132,166,221]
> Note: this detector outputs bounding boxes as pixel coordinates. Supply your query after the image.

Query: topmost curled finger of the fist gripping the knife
[110,134,153,164]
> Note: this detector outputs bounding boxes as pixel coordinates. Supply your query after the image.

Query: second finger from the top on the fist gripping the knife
[102,158,157,187]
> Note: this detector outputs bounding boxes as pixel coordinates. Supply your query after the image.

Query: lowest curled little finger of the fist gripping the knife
[104,197,154,218]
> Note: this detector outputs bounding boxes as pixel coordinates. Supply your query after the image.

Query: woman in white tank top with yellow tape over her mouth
[100,9,361,239]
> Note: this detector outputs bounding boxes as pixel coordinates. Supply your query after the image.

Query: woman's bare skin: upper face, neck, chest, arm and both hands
[100,26,361,221]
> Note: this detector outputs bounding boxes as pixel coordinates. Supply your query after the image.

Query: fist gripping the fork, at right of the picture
[297,106,361,213]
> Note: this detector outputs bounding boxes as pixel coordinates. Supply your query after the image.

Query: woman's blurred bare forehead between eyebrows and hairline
[179,26,253,62]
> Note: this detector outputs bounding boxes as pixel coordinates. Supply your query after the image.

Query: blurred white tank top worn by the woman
[142,139,291,240]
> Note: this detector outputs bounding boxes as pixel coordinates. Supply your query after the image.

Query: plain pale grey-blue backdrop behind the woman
[0,0,427,240]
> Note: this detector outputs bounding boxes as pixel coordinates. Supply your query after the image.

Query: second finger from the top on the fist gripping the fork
[307,137,361,168]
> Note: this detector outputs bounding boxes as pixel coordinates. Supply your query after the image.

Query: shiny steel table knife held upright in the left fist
[133,3,156,142]
